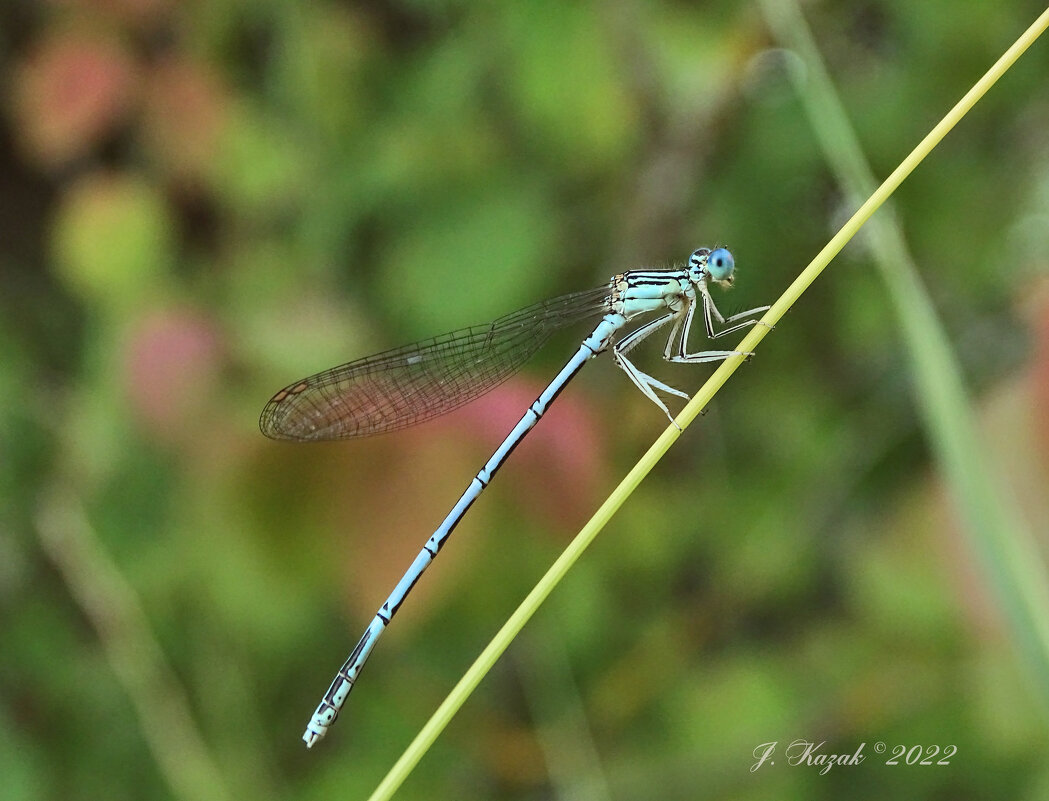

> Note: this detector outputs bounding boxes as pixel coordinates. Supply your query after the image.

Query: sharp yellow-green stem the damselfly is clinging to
[369,9,1049,801]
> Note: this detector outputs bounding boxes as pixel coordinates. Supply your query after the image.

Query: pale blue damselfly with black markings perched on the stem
[259,247,769,746]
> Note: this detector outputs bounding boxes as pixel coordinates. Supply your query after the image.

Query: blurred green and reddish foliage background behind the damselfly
[0,0,1049,801]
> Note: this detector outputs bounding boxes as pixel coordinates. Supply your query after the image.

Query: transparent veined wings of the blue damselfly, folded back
[259,285,611,441]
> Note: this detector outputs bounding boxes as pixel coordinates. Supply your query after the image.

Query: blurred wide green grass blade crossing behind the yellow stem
[762,0,1049,710]
